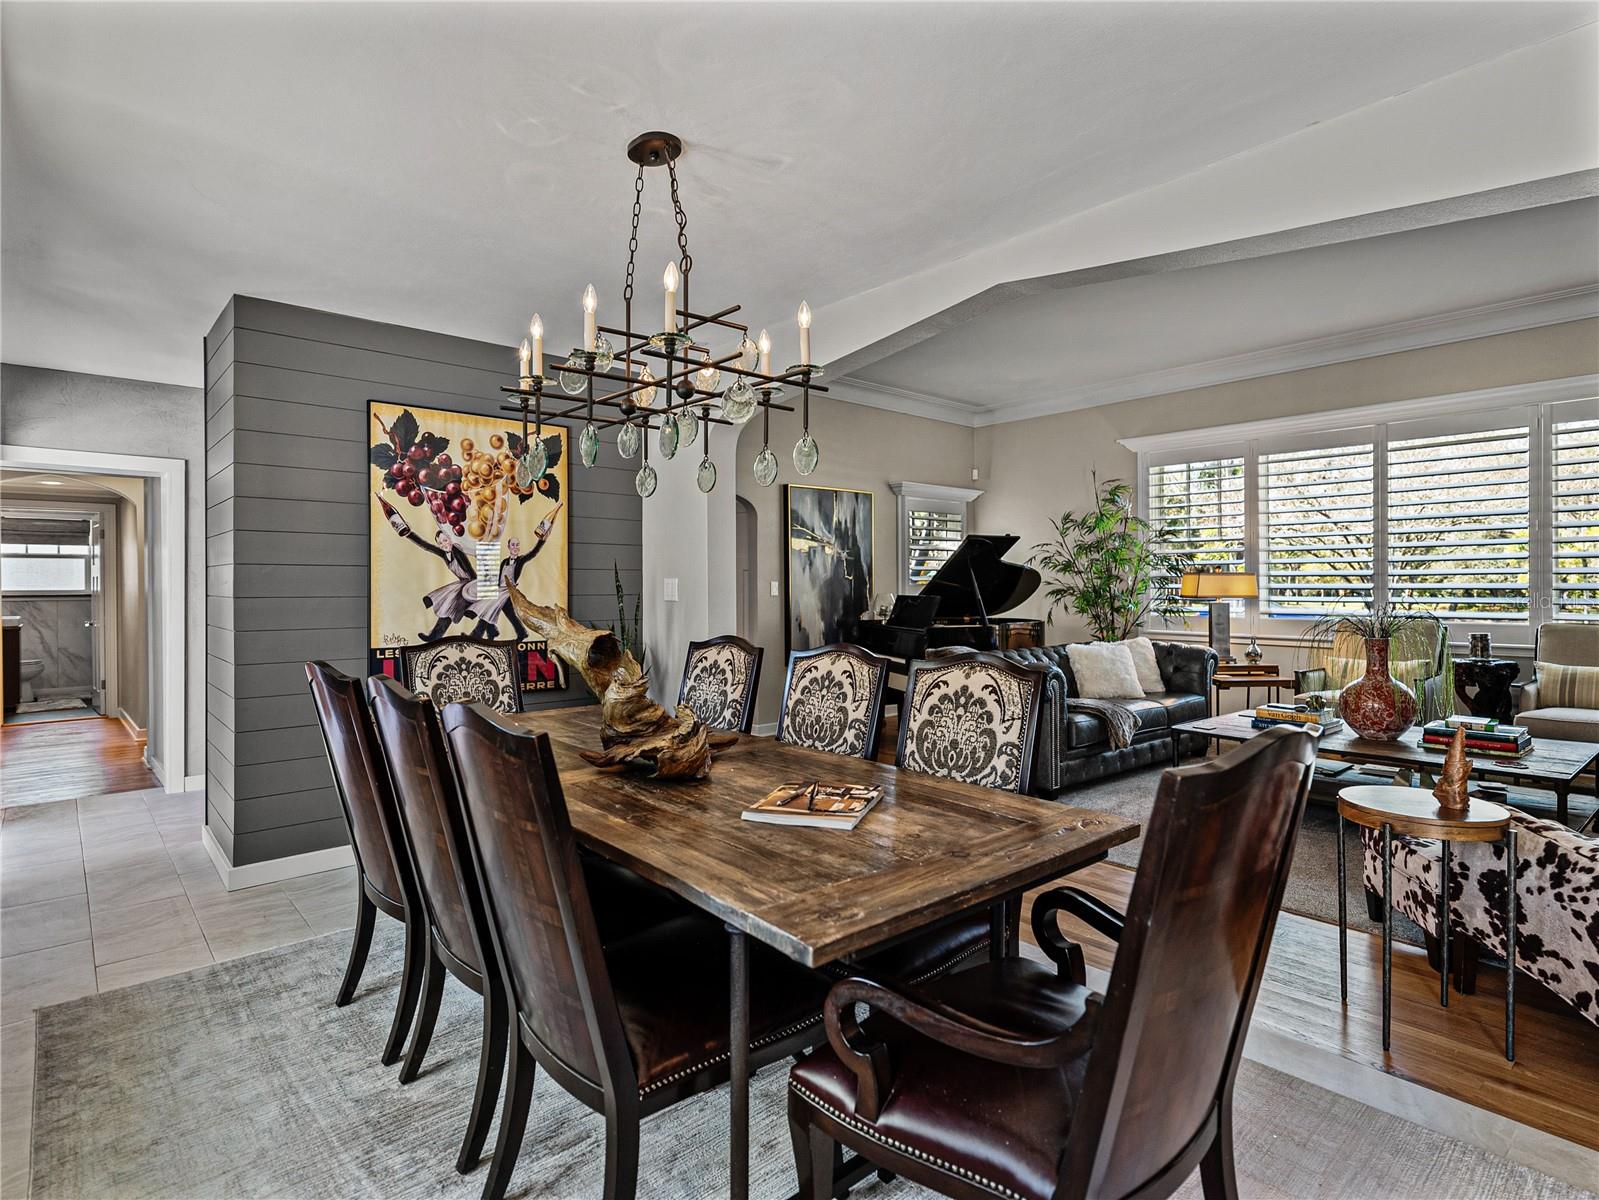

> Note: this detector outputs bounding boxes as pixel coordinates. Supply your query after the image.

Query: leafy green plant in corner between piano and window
[1028,475,1188,642]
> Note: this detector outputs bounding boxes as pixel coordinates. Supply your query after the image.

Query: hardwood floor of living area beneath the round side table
[1022,862,1599,1150]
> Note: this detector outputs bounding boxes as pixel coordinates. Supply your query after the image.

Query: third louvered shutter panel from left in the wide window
[1386,424,1532,622]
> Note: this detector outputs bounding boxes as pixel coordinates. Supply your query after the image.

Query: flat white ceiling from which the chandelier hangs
[0,2,1593,384]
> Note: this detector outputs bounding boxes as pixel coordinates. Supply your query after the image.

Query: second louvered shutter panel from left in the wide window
[1260,442,1377,616]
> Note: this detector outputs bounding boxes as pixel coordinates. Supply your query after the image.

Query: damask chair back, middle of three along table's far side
[777,643,889,758]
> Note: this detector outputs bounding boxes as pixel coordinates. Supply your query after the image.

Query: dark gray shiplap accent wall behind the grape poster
[205,296,643,866]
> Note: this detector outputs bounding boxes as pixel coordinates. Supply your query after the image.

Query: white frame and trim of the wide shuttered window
[1121,374,1599,650]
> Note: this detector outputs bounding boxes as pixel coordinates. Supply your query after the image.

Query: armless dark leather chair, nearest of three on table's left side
[445,704,825,1200]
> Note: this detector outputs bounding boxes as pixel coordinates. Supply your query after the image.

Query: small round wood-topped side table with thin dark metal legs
[1338,786,1516,1062]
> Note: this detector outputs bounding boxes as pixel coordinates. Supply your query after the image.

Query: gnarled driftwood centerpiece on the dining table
[510,586,725,779]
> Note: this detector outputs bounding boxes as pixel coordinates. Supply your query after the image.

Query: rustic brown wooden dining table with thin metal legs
[502,706,1140,1200]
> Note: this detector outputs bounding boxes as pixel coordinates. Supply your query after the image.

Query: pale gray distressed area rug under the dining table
[32,922,1585,1200]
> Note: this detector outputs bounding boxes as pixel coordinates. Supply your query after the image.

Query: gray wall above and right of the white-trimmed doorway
[0,363,206,776]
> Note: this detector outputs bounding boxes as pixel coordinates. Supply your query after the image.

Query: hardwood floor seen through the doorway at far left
[0,717,160,806]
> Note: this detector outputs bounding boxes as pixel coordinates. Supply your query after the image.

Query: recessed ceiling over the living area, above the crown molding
[839,200,1599,424]
